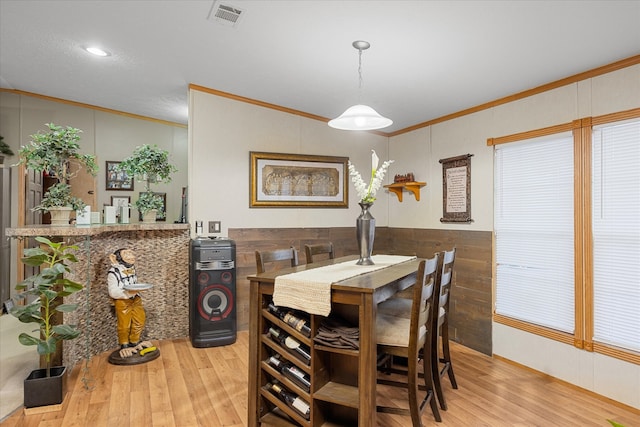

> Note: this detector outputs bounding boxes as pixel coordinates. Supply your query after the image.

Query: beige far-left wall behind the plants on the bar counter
[0,92,187,294]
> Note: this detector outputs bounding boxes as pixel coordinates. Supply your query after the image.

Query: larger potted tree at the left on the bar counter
[18,123,98,225]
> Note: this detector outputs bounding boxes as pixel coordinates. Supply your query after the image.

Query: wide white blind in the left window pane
[494,133,575,333]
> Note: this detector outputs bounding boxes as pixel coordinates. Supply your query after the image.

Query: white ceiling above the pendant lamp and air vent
[0,0,640,132]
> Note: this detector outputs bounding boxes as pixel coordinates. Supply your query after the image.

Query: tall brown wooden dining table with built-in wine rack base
[248,257,419,427]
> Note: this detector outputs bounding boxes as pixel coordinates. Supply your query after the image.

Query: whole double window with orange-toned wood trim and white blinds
[488,109,640,364]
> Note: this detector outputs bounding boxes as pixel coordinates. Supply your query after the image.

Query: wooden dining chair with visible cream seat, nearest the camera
[376,254,442,427]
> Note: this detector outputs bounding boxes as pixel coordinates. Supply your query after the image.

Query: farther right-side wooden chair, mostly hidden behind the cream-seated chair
[431,247,458,410]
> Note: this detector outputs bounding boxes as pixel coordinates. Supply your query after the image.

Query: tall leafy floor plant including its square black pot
[11,237,83,408]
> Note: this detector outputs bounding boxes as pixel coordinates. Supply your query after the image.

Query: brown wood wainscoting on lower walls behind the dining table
[229,227,492,355]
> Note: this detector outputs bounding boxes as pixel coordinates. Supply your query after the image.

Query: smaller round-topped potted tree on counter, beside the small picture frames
[117,144,178,222]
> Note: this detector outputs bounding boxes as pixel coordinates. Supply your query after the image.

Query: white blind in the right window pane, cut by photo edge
[592,120,640,351]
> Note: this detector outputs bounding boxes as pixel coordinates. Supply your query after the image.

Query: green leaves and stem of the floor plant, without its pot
[11,237,83,377]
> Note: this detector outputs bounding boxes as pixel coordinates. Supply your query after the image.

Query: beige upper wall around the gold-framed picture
[189,90,390,236]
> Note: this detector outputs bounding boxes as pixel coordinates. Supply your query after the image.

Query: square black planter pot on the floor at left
[24,366,67,408]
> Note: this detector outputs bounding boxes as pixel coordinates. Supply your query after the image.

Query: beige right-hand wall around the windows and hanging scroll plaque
[389,65,640,408]
